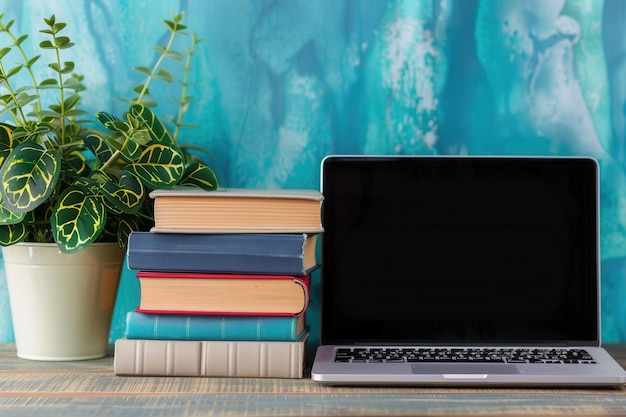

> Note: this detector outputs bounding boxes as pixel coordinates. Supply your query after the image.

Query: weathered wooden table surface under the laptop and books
[0,344,626,417]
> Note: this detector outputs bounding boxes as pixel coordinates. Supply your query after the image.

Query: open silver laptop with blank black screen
[311,155,626,387]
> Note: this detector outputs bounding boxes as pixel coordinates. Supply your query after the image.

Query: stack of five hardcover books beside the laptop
[114,189,322,378]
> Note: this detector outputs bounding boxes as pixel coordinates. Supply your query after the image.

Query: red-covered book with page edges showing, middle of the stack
[137,271,310,316]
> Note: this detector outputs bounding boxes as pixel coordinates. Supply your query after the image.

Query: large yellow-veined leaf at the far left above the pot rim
[0,142,61,213]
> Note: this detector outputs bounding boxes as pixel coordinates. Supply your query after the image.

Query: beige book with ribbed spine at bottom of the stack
[113,337,306,378]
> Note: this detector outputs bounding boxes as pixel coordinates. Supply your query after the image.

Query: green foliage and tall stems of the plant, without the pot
[0,13,218,253]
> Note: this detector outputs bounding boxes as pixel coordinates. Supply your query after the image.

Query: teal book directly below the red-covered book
[125,311,306,341]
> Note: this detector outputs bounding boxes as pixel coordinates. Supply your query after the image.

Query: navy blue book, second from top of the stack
[127,232,318,275]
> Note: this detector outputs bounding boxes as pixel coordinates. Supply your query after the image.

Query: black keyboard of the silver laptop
[335,347,596,364]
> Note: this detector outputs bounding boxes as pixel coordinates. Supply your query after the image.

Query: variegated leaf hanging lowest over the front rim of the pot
[50,185,106,253]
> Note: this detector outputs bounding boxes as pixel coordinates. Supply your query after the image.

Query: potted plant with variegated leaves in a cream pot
[0,13,217,360]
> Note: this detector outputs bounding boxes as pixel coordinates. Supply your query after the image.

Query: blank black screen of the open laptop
[321,156,599,344]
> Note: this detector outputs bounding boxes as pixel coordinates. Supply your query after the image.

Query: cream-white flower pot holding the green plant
[2,243,124,361]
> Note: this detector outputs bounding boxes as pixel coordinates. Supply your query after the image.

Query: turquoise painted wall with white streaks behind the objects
[0,0,626,342]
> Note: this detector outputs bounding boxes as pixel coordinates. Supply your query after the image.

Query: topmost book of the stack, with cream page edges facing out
[150,187,323,233]
